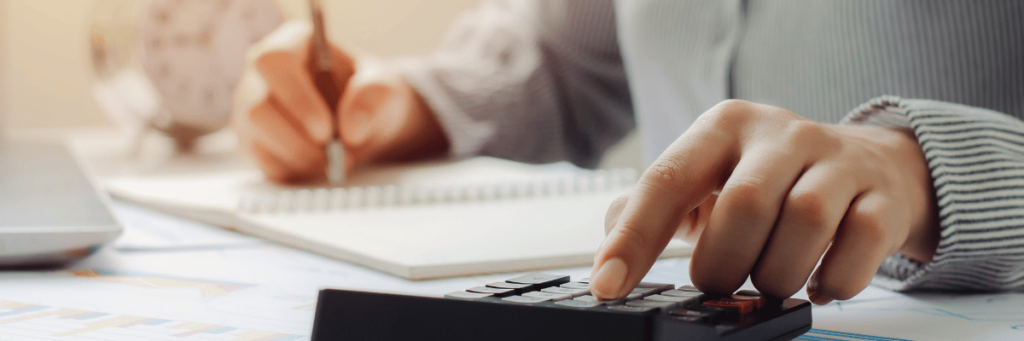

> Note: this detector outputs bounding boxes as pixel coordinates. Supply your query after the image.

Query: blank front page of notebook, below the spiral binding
[239,169,690,279]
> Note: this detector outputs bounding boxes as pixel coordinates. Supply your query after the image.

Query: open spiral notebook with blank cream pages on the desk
[105,158,691,280]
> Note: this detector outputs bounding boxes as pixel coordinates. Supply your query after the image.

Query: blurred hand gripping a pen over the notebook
[231,9,447,183]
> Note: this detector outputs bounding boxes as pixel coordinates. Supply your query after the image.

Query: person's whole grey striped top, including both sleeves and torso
[395,0,1024,290]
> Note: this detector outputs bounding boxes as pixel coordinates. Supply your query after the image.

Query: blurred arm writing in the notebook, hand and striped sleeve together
[232,0,634,181]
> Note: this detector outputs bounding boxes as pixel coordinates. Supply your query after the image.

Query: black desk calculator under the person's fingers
[312,272,811,341]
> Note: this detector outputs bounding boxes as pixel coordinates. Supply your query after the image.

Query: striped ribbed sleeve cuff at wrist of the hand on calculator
[844,96,1024,291]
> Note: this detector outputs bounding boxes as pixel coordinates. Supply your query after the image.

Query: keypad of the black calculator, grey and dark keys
[444,272,769,325]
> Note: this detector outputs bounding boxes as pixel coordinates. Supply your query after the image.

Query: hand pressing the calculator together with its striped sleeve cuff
[591,94,1024,304]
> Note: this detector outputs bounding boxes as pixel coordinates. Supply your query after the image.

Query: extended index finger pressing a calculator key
[590,114,735,299]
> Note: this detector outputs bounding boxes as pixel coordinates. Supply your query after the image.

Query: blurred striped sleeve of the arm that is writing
[394,0,635,167]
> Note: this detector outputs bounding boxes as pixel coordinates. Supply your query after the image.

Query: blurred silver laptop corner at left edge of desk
[0,138,122,268]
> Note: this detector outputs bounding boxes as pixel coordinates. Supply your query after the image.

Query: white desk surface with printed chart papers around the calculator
[0,202,1024,341]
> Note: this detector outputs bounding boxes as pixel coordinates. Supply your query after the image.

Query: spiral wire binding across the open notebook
[238,168,638,214]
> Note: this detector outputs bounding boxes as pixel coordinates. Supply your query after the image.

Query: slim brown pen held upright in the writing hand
[309,0,345,185]
